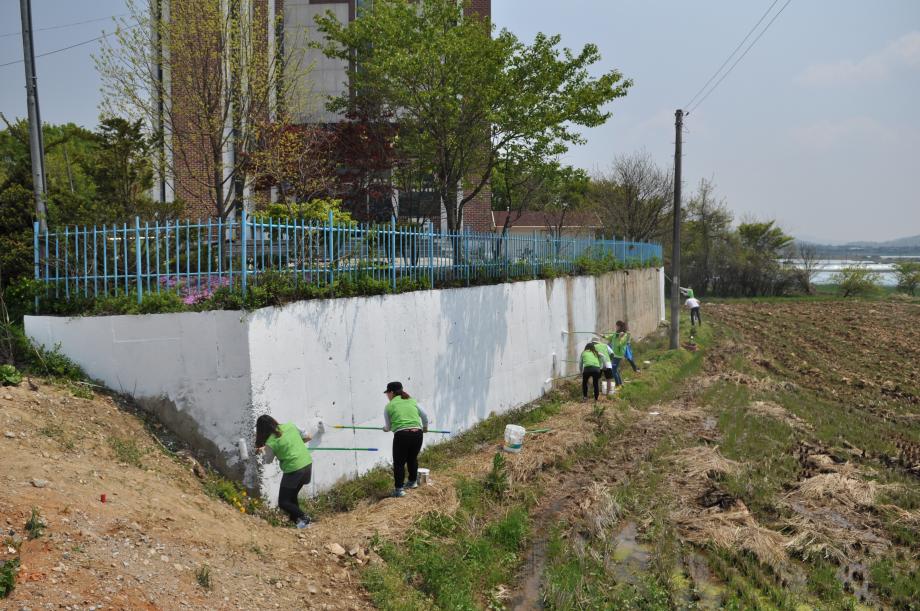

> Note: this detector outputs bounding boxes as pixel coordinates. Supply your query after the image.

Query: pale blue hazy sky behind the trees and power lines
[0,0,920,242]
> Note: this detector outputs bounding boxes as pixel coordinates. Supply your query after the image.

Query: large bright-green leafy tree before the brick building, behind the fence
[317,0,631,231]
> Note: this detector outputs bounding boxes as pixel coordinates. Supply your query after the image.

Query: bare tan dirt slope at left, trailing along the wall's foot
[0,382,589,610]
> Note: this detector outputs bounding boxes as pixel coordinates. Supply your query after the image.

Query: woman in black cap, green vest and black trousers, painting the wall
[383,382,428,497]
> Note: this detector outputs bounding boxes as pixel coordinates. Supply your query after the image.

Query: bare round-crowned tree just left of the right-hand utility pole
[590,152,674,241]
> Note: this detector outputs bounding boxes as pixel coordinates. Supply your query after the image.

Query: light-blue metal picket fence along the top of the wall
[34,212,661,303]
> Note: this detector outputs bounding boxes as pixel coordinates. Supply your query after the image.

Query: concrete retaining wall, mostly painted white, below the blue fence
[26,270,663,500]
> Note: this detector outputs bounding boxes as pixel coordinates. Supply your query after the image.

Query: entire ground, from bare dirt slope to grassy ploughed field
[0,301,920,609]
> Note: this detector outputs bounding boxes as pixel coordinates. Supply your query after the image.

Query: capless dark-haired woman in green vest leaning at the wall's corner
[256,414,313,528]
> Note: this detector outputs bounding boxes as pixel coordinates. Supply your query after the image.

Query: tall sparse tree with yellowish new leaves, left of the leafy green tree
[95,0,298,218]
